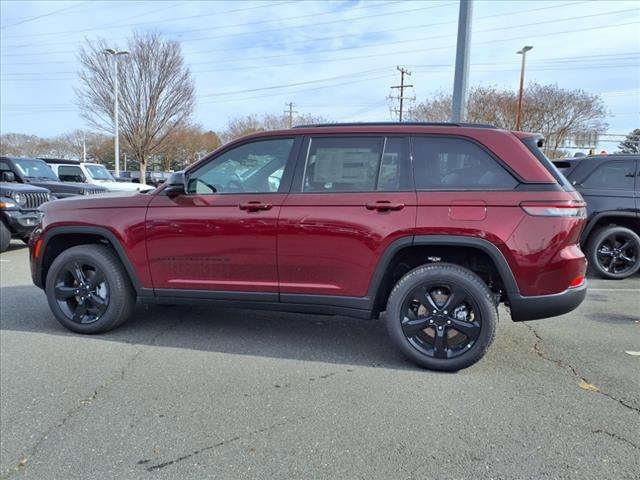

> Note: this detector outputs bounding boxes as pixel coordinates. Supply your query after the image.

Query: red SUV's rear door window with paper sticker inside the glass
[303,137,410,192]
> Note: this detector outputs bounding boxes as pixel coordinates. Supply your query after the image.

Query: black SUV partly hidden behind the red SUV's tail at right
[553,154,640,279]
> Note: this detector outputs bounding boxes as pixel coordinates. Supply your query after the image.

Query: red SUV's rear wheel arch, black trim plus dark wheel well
[367,235,519,315]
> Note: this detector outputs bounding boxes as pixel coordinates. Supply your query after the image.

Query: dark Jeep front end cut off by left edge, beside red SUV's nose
[0,182,51,252]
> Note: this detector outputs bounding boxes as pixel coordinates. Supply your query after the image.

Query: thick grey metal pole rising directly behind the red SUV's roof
[451,0,473,122]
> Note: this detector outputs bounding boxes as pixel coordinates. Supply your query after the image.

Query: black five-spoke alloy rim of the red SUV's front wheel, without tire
[54,260,109,324]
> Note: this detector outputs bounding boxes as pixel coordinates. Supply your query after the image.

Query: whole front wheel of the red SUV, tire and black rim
[45,245,136,334]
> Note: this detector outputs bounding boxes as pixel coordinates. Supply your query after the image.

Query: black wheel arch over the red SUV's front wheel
[37,227,146,295]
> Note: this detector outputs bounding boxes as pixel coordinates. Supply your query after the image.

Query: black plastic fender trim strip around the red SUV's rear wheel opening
[367,235,520,299]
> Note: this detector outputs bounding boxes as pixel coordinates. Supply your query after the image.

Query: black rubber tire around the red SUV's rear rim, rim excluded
[386,263,498,371]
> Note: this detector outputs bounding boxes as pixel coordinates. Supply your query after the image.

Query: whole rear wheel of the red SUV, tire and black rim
[386,263,498,371]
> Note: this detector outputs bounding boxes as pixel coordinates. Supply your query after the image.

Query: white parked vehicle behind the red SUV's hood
[42,158,153,192]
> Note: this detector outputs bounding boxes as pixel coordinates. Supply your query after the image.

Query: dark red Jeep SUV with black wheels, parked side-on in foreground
[30,124,586,370]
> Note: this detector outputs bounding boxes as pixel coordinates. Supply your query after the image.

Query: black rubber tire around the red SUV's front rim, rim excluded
[45,245,135,334]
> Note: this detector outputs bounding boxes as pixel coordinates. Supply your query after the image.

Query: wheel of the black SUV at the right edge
[587,225,640,280]
